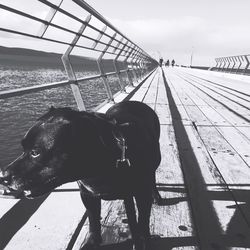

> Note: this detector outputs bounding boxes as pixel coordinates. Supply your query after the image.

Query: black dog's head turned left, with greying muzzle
[0,108,101,198]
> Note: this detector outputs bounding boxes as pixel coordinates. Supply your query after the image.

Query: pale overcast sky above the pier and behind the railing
[0,0,250,66]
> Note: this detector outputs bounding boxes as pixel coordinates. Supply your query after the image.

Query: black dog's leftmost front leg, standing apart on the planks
[81,192,102,249]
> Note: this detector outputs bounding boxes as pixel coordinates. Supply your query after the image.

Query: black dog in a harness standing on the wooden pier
[0,101,161,250]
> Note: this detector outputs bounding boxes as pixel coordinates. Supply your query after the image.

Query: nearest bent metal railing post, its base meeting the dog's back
[61,15,91,111]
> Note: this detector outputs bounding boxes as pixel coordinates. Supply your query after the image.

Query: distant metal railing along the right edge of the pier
[213,55,250,75]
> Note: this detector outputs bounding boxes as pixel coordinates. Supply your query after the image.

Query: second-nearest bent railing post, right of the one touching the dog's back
[97,33,116,102]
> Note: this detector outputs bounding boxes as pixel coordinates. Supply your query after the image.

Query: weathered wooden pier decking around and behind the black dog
[0,68,250,250]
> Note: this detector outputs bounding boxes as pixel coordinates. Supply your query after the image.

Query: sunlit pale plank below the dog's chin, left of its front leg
[5,183,85,250]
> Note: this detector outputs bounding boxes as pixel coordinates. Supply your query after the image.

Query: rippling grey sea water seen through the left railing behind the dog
[0,63,125,168]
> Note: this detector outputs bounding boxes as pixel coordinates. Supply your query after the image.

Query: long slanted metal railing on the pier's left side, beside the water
[0,0,158,110]
